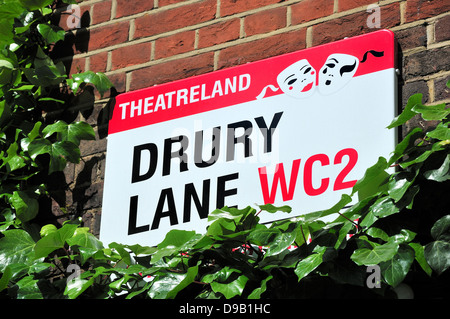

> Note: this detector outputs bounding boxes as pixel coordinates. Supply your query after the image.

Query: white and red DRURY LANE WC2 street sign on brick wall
[100,30,397,245]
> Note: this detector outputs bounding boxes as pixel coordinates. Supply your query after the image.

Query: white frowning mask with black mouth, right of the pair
[318,53,359,95]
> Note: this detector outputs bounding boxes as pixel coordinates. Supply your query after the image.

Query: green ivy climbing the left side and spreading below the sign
[0,0,450,299]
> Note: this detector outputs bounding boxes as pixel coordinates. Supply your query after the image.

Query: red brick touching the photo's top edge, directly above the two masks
[291,0,334,25]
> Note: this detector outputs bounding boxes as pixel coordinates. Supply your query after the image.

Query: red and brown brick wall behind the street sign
[53,0,450,234]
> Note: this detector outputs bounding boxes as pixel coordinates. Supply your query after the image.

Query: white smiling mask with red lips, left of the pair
[277,59,316,98]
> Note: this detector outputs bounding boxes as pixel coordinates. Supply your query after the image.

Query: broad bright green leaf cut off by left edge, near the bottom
[0,229,35,271]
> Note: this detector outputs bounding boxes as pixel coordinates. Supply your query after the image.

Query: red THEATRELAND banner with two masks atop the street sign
[109,30,396,134]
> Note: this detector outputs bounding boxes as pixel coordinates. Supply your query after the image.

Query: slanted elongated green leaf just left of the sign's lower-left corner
[35,224,78,258]
